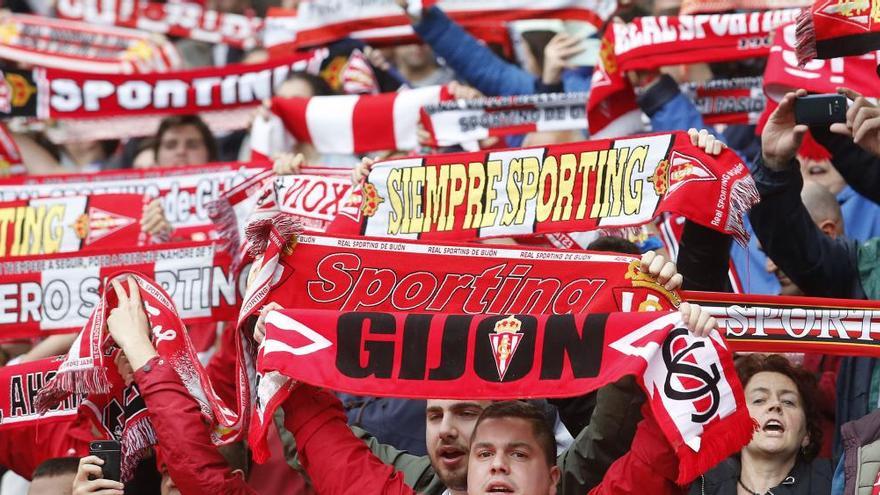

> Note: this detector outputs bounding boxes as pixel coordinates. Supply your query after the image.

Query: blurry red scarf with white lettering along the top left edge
[56,0,263,50]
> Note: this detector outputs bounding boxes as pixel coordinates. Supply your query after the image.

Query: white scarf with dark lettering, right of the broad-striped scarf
[421,93,588,146]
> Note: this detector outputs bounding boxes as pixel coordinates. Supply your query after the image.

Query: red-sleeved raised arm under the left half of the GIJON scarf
[282,384,415,495]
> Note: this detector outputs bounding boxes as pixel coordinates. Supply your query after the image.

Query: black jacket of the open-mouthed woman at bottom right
[688,457,833,495]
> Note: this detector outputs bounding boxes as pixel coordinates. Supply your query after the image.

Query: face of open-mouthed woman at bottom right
[745,371,810,457]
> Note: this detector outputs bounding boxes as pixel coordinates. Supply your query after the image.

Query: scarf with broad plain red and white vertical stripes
[272,86,449,154]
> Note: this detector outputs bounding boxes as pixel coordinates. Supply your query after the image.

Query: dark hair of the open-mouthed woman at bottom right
[736,354,822,462]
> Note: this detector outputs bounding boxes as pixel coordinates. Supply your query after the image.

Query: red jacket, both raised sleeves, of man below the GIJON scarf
[282,385,684,495]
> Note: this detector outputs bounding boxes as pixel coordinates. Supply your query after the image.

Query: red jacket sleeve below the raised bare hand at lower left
[134,357,257,495]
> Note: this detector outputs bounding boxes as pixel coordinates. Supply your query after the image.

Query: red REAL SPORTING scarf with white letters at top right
[609,9,799,72]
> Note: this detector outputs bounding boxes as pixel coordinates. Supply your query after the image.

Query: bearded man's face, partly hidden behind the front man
[425,400,491,490]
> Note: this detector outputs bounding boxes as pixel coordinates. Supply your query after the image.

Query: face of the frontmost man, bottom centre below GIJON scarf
[467,418,559,495]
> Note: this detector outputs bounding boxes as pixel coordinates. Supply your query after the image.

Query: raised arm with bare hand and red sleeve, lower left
[107,278,256,495]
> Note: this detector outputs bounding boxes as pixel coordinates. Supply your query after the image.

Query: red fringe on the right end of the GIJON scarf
[675,406,755,486]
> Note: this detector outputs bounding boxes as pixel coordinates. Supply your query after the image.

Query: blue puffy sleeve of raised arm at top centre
[413,6,539,96]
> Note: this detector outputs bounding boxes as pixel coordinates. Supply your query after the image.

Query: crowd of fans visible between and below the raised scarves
[0,0,880,495]
